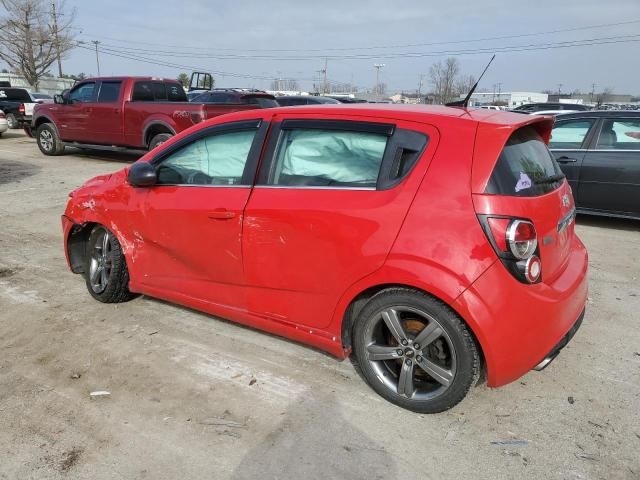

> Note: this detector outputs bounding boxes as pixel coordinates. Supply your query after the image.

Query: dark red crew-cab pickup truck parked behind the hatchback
[27,77,273,155]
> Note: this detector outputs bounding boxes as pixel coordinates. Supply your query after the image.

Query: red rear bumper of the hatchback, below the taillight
[453,237,588,387]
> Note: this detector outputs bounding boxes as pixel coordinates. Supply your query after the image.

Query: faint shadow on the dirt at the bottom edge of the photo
[231,392,398,480]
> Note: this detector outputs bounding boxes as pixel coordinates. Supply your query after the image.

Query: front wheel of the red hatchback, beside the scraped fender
[84,225,135,303]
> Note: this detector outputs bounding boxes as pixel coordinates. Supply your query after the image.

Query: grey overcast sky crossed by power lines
[56,0,640,94]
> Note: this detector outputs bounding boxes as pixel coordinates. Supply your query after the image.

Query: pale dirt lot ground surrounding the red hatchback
[0,128,640,480]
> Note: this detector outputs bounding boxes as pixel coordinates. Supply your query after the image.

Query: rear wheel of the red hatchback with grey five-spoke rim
[353,288,480,413]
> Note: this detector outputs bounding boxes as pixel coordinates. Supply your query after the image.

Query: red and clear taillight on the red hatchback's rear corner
[478,215,542,283]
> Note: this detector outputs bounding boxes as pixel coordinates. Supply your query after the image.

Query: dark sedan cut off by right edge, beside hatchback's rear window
[549,111,640,219]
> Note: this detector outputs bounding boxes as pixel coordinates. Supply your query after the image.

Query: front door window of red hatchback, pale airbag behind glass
[158,128,257,185]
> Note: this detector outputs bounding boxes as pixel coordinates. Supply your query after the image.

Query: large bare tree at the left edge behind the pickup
[0,0,75,90]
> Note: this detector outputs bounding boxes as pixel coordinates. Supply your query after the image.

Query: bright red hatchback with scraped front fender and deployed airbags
[62,104,587,413]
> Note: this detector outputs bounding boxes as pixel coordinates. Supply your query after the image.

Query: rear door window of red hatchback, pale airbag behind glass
[268,128,388,187]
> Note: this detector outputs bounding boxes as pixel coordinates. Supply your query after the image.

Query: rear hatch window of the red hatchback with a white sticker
[485,127,564,197]
